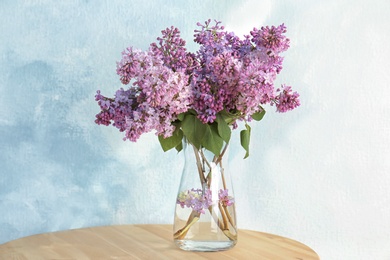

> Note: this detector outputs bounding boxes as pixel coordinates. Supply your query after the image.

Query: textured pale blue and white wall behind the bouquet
[0,0,390,259]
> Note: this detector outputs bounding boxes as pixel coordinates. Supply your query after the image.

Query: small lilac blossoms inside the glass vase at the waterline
[177,189,234,214]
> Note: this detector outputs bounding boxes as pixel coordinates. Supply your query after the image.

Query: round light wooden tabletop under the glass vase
[0,225,319,260]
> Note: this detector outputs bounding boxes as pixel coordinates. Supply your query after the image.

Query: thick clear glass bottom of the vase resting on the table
[175,240,237,252]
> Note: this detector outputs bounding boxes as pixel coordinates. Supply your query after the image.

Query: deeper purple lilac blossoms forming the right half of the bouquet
[191,20,299,123]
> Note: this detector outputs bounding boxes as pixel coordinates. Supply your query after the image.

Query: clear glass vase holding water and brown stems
[173,142,237,251]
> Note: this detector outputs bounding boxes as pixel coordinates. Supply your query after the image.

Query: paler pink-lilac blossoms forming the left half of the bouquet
[95,28,193,141]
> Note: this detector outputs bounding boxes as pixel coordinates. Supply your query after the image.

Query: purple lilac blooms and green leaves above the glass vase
[95,20,299,158]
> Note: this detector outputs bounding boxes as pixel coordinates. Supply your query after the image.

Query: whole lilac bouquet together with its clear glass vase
[95,20,299,248]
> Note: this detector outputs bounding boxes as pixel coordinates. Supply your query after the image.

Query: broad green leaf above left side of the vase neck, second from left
[181,114,207,149]
